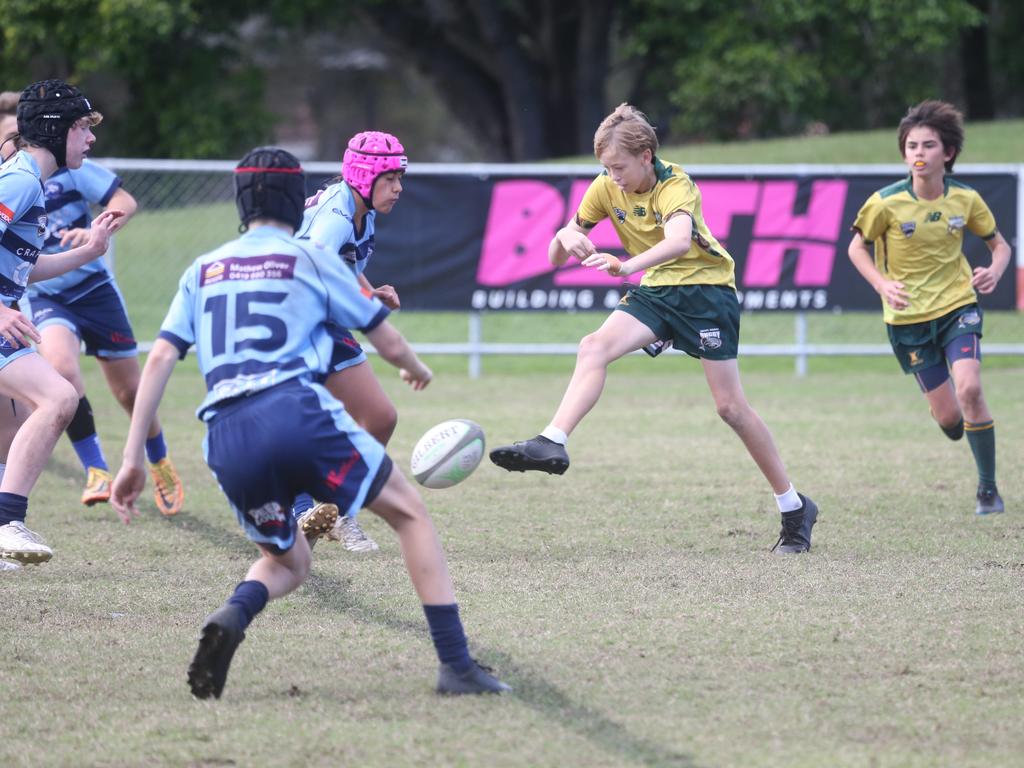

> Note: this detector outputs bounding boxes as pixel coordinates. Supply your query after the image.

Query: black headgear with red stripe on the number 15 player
[234,146,306,231]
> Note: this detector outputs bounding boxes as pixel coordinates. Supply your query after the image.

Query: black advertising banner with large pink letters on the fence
[367,172,1018,311]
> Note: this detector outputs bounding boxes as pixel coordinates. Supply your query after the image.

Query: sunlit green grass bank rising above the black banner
[569,120,1024,166]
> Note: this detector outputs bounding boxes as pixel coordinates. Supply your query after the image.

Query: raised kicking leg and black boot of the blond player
[490,312,657,475]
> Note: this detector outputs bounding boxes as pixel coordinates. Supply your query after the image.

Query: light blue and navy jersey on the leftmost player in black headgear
[0,151,46,304]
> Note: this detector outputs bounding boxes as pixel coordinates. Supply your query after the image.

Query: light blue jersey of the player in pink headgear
[296,181,377,274]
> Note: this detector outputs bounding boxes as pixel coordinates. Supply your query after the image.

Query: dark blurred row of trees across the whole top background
[0,0,1024,161]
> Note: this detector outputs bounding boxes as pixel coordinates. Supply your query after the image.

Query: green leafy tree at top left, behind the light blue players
[0,0,272,158]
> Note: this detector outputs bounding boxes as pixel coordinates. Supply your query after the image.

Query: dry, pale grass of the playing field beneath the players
[0,350,1024,768]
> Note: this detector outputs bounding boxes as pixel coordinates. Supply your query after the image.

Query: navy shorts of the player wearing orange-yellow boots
[29,283,138,358]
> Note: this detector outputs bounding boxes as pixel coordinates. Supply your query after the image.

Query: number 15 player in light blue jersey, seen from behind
[111,147,508,698]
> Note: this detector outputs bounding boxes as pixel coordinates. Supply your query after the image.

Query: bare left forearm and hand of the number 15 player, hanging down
[111,339,179,524]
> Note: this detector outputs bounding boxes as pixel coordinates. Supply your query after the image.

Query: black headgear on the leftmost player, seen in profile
[17,80,94,168]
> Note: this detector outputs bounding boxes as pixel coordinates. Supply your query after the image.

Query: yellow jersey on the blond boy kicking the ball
[577,158,736,288]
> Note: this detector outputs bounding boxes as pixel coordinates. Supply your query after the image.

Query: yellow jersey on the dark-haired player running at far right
[853,177,996,326]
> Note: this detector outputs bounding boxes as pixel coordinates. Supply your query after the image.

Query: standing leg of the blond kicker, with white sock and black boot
[700,358,818,554]
